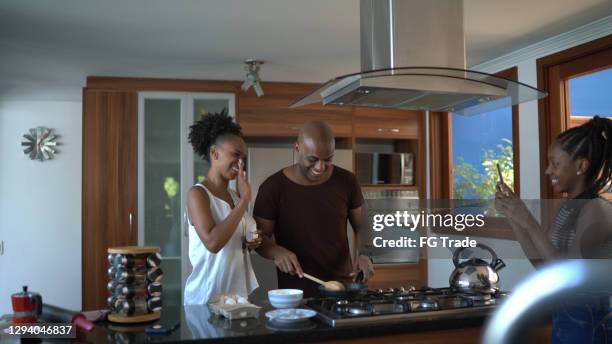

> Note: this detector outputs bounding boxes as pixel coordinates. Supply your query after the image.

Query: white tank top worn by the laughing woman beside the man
[183,184,259,305]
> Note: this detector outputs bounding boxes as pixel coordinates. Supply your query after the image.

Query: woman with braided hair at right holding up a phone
[495,116,612,343]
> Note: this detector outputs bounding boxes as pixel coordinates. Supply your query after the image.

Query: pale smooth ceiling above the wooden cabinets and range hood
[0,0,612,100]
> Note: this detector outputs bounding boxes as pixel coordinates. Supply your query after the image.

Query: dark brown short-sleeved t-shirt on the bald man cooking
[253,165,363,297]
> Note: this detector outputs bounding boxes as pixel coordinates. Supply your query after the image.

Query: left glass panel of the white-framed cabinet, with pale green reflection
[138,93,183,306]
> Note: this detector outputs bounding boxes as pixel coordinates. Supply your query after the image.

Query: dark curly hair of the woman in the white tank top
[189,109,242,162]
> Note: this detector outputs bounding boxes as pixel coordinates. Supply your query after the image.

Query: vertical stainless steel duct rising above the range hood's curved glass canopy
[360,0,466,72]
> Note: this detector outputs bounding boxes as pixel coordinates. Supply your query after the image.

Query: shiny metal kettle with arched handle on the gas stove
[448,244,506,293]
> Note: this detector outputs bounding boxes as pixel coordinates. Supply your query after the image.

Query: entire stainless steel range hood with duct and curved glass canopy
[290,0,547,115]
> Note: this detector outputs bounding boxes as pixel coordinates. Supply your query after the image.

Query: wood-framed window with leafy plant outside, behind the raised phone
[430,67,520,239]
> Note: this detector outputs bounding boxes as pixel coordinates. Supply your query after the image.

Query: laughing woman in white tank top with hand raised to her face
[183,110,261,305]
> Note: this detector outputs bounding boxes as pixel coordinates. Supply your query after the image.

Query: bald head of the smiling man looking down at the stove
[295,121,336,183]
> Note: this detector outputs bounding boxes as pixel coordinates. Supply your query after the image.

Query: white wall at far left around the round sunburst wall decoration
[0,100,82,314]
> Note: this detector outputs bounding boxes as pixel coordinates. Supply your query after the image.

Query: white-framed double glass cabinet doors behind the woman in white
[138,92,235,307]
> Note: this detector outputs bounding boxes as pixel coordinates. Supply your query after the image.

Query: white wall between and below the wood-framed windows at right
[428,16,612,290]
